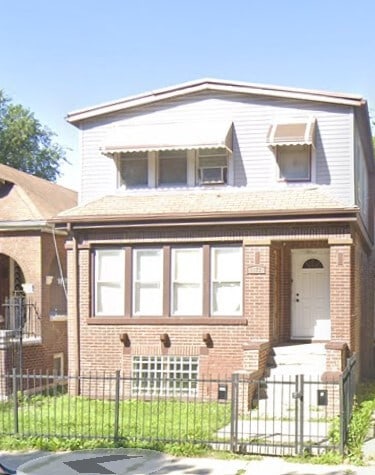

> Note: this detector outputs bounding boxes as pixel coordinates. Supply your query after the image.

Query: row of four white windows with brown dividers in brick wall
[92,244,243,318]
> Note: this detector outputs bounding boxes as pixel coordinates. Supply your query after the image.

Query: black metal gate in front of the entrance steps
[231,375,342,455]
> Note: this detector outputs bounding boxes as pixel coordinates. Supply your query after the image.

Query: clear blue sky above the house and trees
[0,0,375,189]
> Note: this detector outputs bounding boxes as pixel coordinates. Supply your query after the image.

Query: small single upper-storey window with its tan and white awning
[267,117,316,182]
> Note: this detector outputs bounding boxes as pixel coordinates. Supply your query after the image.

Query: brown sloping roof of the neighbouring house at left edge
[0,164,77,222]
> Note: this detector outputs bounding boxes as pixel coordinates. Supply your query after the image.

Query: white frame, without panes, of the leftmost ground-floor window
[94,248,125,317]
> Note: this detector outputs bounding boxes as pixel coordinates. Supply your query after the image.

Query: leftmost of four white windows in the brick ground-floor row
[95,249,125,316]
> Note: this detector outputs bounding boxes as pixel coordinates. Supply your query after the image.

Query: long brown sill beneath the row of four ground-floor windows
[86,317,247,326]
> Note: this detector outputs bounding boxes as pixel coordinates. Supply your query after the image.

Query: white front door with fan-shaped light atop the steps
[291,249,331,340]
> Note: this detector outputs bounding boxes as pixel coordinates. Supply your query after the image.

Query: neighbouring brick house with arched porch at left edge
[0,164,77,388]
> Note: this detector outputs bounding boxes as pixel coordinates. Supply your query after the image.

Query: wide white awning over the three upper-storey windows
[101,121,232,155]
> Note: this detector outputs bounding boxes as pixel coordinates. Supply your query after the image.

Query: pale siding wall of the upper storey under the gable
[81,92,354,205]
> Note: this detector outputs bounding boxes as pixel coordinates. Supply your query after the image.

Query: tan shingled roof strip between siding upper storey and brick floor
[56,187,356,222]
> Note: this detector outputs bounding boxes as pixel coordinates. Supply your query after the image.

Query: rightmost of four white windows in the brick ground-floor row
[211,247,242,315]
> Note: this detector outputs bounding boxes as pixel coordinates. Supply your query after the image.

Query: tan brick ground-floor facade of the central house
[67,220,373,390]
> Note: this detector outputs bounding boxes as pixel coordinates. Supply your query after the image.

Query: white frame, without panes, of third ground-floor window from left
[170,246,203,316]
